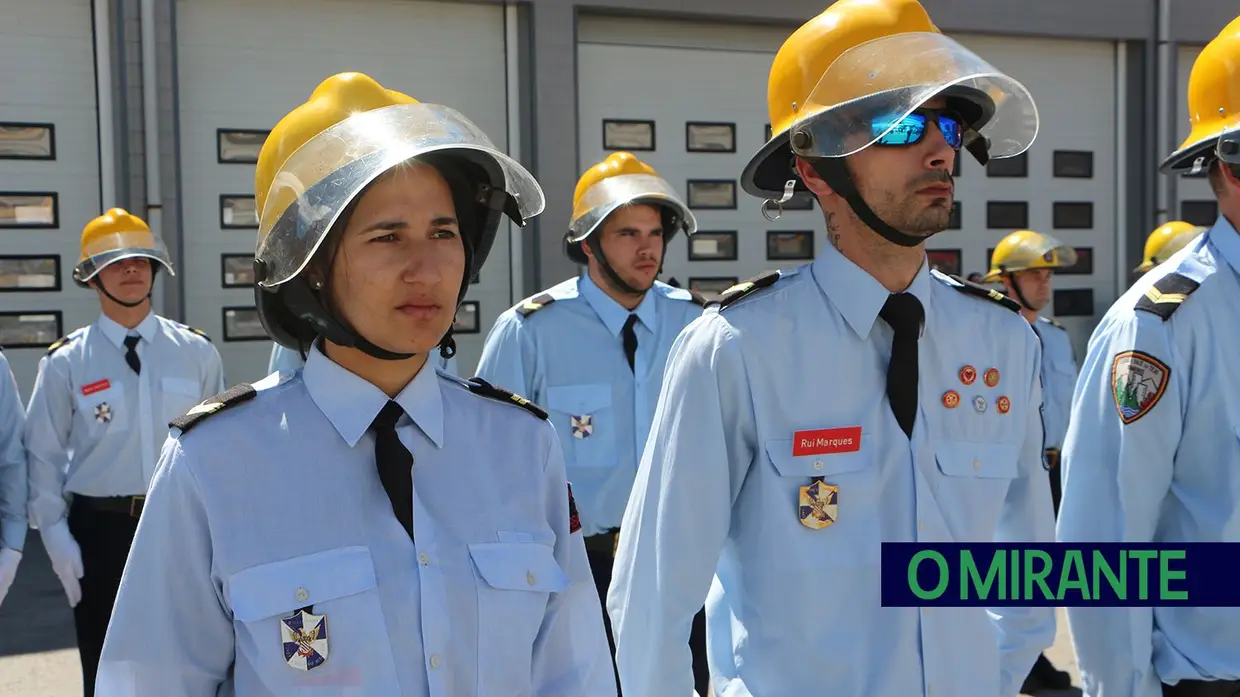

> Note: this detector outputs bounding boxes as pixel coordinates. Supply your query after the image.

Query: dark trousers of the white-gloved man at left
[68,495,144,697]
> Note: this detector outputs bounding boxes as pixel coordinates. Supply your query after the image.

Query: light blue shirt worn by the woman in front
[97,349,616,697]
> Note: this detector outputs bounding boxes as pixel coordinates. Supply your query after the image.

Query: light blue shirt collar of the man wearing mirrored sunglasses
[810,235,932,339]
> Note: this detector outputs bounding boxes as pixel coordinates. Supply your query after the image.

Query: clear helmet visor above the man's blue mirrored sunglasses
[791,32,1038,159]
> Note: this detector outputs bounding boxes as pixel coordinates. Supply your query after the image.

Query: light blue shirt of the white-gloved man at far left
[25,313,224,530]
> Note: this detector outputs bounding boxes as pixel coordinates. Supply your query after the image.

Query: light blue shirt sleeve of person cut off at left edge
[0,353,29,552]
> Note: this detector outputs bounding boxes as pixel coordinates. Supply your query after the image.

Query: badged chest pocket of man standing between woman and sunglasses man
[546,383,618,468]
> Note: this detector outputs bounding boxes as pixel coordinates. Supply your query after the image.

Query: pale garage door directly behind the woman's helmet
[177,0,512,383]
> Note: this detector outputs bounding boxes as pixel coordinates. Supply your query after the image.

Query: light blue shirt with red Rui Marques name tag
[608,238,1055,697]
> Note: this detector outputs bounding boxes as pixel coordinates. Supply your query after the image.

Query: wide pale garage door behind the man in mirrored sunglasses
[578,16,1117,351]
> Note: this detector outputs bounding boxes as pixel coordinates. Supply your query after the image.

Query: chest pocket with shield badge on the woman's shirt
[228,547,399,695]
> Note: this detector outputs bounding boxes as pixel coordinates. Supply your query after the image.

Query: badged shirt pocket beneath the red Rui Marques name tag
[766,440,883,568]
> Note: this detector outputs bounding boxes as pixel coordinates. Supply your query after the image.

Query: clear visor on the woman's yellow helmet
[255,104,546,288]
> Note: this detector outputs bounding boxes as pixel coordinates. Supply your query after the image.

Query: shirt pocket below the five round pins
[935,440,1021,530]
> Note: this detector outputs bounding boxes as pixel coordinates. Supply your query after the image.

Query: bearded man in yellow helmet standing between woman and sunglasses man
[477,153,708,690]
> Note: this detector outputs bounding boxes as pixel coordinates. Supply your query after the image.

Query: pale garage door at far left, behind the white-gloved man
[0,0,101,399]
